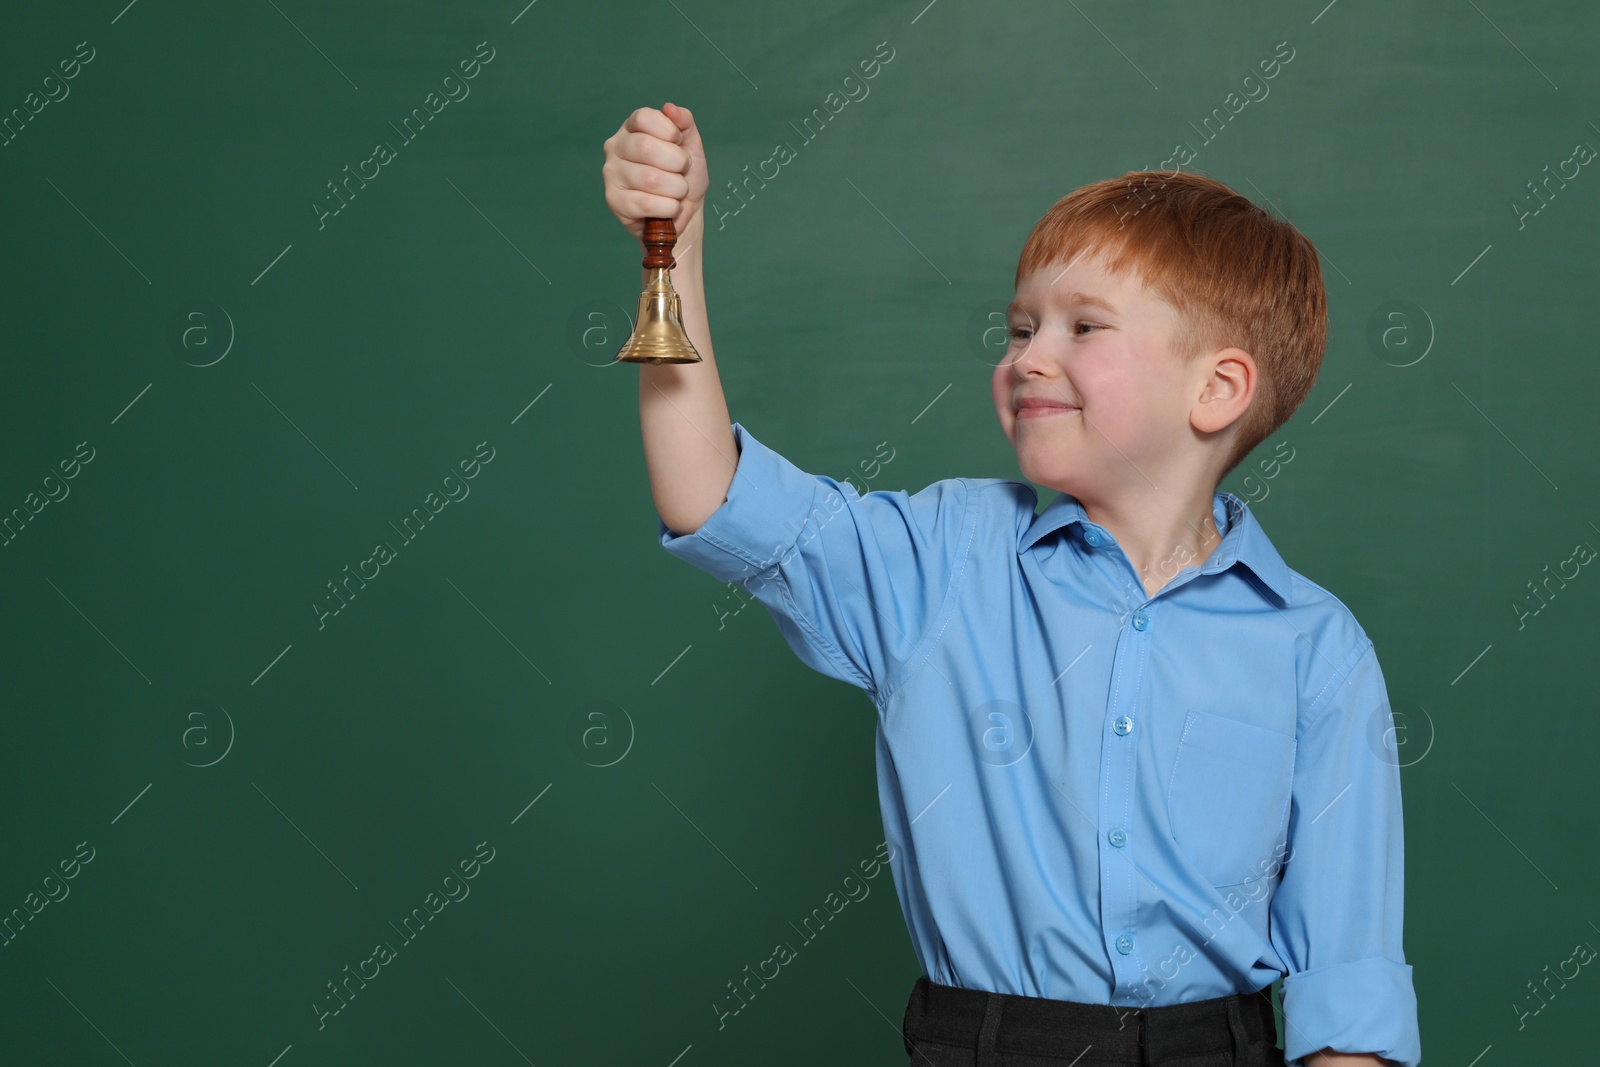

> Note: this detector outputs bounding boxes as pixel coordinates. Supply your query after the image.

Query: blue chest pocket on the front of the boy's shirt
[1166,710,1294,888]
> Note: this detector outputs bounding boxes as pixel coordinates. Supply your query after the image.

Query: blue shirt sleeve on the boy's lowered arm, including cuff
[1270,635,1422,1067]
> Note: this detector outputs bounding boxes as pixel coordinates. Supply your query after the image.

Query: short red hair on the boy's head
[1016,171,1328,483]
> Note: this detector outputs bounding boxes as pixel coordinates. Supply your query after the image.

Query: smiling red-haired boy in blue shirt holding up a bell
[602,104,1421,1067]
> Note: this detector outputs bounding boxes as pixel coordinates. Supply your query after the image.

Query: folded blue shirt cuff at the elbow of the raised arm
[656,422,818,582]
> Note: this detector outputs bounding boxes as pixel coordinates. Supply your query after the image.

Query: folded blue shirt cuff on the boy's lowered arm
[1283,957,1422,1067]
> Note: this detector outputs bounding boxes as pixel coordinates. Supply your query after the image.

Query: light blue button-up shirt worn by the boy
[656,422,1421,1067]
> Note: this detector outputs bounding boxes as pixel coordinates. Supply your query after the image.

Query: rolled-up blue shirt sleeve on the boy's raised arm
[656,422,973,699]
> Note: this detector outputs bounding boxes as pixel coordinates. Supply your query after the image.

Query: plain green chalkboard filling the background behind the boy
[0,0,1600,1067]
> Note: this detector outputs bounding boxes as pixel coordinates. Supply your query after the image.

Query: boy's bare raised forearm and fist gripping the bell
[600,102,739,534]
